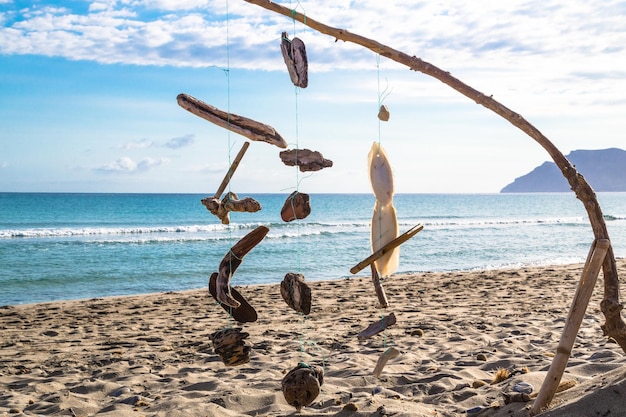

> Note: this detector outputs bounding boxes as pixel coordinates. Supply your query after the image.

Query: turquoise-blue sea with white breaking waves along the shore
[0,193,626,305]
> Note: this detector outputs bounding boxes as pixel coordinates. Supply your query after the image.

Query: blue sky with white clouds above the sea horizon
[0,0,626,194]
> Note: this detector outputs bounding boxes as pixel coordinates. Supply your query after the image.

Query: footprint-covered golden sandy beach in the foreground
[0,259,626,417]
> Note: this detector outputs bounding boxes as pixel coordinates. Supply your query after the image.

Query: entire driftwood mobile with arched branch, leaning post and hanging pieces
[178,0,626,415]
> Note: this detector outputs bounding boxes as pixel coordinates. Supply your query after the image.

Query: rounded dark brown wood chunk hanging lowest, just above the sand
[281,363,324,411]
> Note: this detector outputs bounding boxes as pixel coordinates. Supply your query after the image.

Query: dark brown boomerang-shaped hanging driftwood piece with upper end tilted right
[215,226,270,308]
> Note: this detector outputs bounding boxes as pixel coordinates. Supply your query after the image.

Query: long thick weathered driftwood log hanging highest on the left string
[176,94,287,149]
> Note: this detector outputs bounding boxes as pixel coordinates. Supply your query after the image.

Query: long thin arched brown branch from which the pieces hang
[240,0,626,352]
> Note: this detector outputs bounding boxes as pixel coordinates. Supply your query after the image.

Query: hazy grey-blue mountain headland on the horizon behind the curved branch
[500,148,626,193]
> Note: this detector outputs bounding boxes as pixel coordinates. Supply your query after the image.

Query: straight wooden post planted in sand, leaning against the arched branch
[530,239,611,416]
